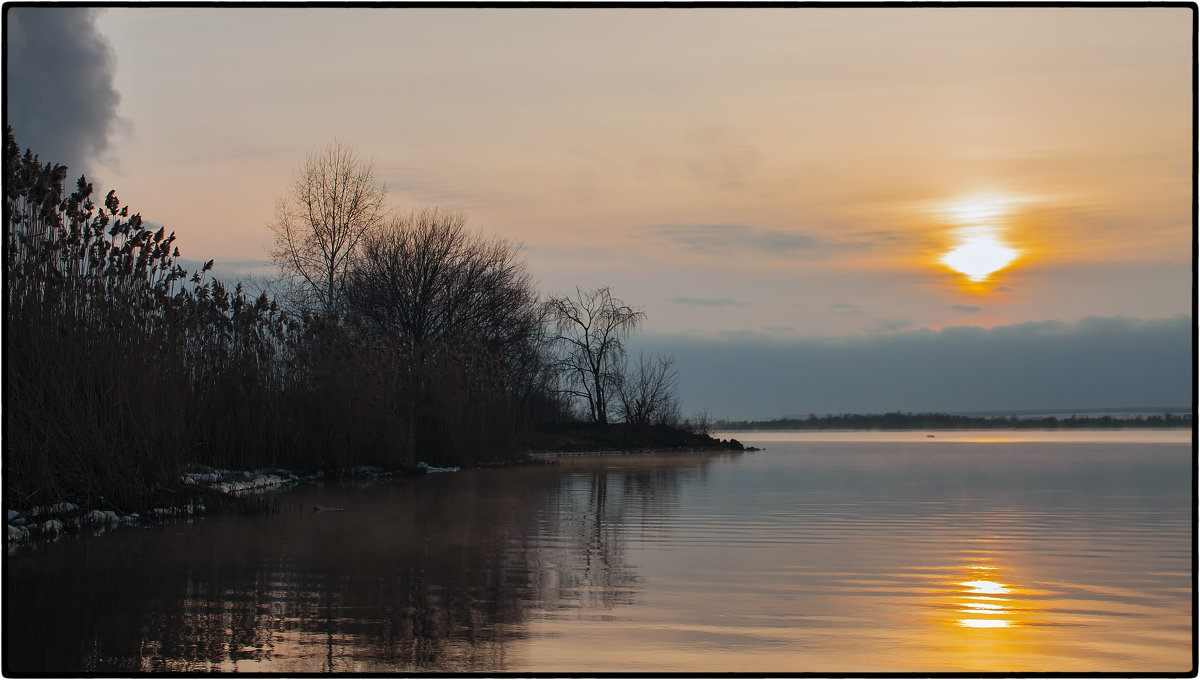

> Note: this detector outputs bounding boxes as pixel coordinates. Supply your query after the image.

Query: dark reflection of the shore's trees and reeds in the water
[5,453,728,673]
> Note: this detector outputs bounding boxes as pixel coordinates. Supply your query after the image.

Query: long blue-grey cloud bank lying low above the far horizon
[631,317,1195,417]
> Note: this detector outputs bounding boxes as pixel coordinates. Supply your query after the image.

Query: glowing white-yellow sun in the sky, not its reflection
[938,194,1021,283]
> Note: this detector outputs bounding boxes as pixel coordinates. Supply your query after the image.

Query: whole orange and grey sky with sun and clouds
[6,6,1195,417]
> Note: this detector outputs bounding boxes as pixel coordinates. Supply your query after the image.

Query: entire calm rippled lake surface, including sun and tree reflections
[4,431,1194,674]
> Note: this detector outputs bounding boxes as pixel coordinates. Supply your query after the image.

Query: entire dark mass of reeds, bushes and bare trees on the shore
[5,128,691,505]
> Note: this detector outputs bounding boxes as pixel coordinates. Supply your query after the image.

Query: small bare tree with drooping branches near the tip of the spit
[547,288,646,425]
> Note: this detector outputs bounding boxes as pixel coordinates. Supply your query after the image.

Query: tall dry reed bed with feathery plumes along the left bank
[4,130,522,506]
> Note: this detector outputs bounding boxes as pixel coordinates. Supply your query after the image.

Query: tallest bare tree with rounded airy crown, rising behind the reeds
[271,140,386,313]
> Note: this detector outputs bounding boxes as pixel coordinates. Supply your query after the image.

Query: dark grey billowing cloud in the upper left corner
[5,6,120,175]
